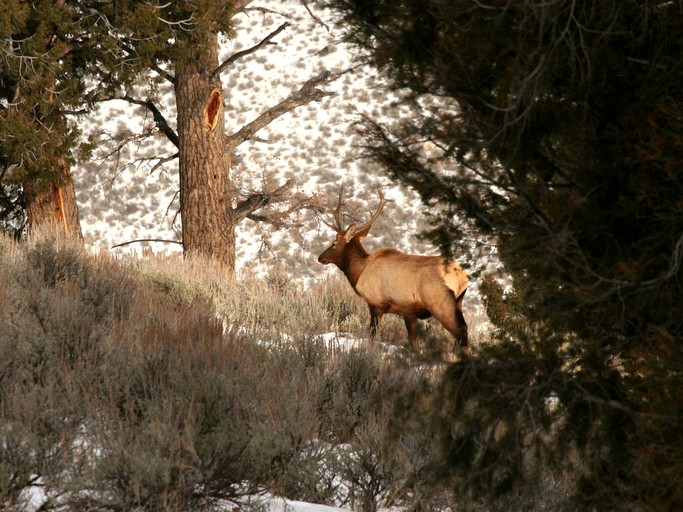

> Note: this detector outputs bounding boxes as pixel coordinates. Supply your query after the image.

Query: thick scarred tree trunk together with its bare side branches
[171,28,331,276]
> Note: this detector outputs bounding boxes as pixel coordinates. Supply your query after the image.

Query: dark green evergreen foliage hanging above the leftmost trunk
[0,1,85,178]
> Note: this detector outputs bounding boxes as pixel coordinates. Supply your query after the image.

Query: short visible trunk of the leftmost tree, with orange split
[22,158,83,244]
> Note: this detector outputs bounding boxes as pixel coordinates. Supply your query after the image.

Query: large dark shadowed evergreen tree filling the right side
[333,0,683,510]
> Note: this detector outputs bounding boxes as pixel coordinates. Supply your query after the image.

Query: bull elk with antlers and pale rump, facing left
[318,187,468,352]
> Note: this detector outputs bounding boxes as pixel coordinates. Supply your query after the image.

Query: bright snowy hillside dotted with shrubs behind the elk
[74,0,435,276]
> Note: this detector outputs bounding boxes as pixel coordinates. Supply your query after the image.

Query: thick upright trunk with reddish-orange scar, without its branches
[175,35,236,275]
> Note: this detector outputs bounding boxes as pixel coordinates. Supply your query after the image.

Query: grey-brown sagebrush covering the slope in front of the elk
[0,232,460,510]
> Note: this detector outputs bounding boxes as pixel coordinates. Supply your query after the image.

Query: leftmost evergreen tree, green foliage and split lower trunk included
[0,0,84,240]
